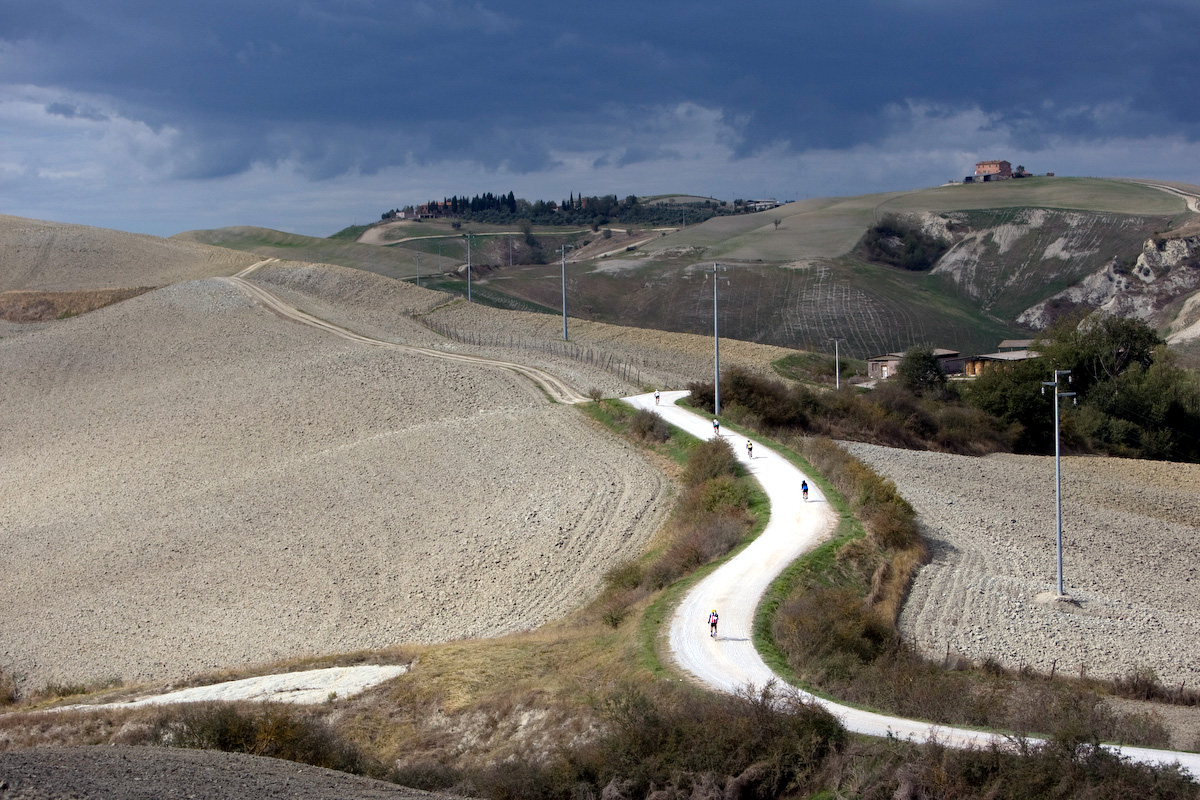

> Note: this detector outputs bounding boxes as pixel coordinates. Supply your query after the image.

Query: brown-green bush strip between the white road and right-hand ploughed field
[772,438,1176,746]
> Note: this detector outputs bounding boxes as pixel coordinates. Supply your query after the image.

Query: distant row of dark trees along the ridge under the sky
[380,191,751,228]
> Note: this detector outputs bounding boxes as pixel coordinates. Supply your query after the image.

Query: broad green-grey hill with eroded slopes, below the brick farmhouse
[422,178,1195,356]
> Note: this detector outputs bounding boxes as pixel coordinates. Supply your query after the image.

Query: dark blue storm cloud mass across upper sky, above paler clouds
[0,0,1200,178]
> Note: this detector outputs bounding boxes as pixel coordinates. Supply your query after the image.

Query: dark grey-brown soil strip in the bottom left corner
[0,746,449,800]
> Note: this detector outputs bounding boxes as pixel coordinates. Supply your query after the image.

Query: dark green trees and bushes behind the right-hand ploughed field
[691,315,1200,462]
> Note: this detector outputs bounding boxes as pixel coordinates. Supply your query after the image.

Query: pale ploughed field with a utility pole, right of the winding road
[846,444,1200,688]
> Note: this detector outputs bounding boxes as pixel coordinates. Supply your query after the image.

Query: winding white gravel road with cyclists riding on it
[625,392,1200,777]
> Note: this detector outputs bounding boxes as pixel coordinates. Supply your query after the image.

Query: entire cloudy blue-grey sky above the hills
[0,0,1200,236]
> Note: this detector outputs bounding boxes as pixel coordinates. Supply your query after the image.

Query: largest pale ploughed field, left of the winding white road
[0,270,671,687]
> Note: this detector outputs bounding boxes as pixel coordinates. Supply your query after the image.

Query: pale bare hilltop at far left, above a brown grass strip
[0,215,258,291]
